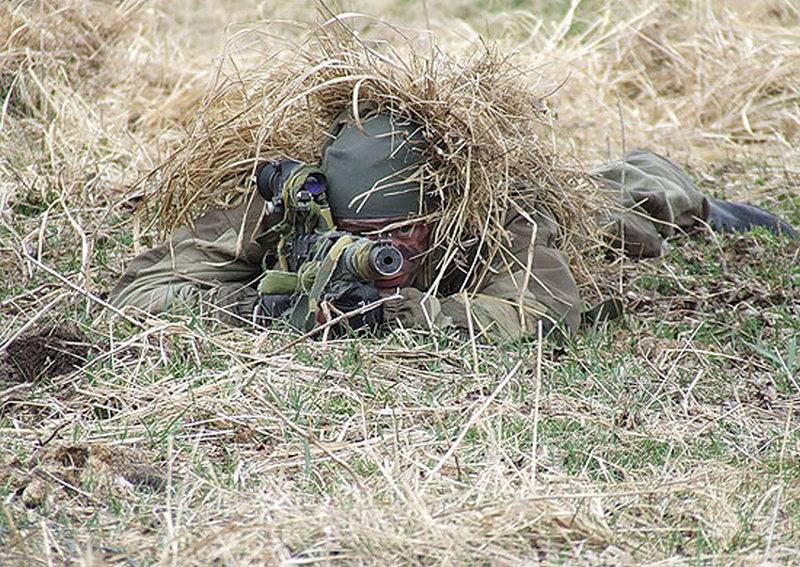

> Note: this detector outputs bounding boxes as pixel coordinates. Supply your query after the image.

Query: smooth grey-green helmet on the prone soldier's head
[321,114,424,219]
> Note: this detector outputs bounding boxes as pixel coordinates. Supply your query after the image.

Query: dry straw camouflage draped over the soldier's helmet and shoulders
[148,15,605,296]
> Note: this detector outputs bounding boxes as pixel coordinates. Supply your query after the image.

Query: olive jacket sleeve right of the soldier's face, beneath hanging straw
[441,207,581,342]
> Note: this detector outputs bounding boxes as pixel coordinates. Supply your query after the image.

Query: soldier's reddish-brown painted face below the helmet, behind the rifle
[336,215,431,294]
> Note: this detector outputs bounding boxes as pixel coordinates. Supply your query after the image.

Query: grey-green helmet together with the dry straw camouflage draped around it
[153,14,608,297]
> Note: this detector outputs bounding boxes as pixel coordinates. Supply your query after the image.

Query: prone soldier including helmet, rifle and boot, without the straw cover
[111,106,797,341]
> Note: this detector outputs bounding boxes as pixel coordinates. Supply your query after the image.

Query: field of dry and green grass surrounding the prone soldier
[0,0,800,565]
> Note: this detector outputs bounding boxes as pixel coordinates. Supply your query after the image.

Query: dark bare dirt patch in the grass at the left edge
[0,325,92,382]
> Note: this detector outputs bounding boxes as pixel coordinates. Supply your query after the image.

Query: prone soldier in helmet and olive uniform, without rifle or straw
[111,105,797,341]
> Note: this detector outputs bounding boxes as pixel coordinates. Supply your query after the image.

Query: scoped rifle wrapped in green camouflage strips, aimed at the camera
[256,159,403,330]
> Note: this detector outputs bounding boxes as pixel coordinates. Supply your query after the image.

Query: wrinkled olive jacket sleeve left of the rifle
[109,202,268,324]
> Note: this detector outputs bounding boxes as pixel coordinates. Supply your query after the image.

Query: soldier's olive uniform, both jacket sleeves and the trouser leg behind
[110,150,707,341]
